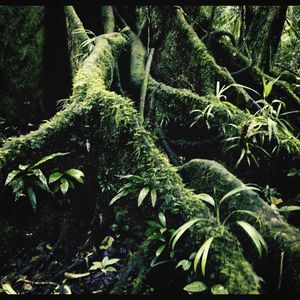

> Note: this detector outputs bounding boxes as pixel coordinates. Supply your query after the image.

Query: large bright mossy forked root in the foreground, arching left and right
[0,23,259,293]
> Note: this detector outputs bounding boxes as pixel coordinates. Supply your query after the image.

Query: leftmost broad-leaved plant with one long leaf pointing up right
[4,152,68,211]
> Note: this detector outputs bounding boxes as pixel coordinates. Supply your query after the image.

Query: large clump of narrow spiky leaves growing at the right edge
[223,77,299,167]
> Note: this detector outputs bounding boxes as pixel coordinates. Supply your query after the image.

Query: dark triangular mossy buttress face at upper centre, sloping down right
[148,10,248,106]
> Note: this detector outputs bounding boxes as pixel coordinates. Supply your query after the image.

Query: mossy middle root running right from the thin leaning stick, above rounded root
[147,79,300,190]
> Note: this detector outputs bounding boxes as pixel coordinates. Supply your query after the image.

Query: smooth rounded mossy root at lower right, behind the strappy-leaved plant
[178,159,300,290]
